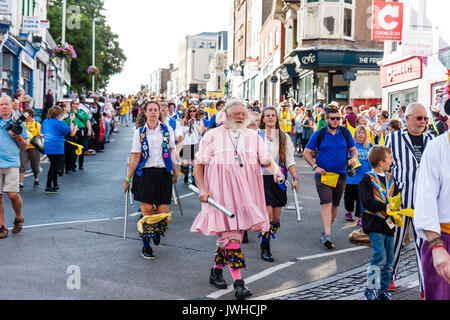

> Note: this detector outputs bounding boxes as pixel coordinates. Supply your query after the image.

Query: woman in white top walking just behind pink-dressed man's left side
[180,105,205,184]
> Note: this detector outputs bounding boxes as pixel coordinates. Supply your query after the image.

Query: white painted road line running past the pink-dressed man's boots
[207,247,368,299]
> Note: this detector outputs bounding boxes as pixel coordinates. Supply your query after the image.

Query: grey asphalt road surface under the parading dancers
[0,128,418,299]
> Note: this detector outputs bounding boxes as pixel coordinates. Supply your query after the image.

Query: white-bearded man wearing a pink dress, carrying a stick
[191,100,284,299]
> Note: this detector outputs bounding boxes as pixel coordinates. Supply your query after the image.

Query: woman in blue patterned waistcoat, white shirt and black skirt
[123,101,177,260]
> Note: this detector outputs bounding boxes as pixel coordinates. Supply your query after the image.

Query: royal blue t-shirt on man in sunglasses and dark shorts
[306,126,355,178]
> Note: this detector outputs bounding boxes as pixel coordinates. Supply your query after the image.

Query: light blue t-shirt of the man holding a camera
[0,116,28,169]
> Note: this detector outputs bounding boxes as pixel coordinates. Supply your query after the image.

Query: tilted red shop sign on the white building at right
[380,57,422,88]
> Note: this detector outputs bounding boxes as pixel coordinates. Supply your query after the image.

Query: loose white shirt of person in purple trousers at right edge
[414,132,450,239]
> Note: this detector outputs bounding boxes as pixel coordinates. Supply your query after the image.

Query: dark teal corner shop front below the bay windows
[295,49,383,107]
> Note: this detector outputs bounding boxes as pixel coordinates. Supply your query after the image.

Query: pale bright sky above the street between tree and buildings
[105,0,233,94]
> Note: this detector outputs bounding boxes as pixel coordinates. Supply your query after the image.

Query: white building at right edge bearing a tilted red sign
[380,0,450,114]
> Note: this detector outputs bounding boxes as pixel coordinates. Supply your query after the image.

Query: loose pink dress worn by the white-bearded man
[191,126,271,238]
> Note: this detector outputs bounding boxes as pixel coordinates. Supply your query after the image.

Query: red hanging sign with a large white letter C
[372,1,403,41]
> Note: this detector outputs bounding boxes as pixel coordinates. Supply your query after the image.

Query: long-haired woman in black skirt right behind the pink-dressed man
[259,107,298,262]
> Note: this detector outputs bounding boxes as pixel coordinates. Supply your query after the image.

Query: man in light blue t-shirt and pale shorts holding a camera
[0,96,28,239]
